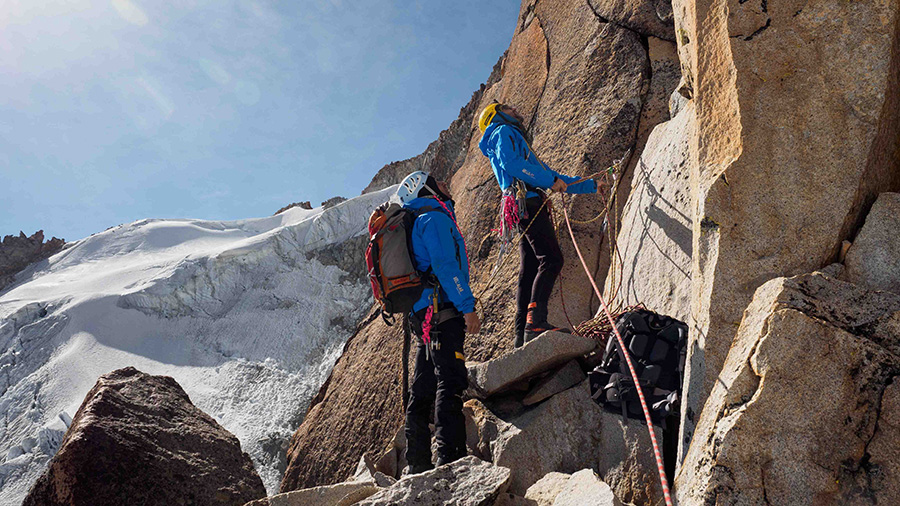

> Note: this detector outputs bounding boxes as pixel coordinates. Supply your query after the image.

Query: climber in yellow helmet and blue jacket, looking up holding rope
[478,102,598,347]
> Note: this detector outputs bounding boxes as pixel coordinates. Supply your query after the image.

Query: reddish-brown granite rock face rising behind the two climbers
[281,0,665,492]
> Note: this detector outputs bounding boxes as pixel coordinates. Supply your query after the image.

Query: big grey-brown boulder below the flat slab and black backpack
[463,381,663,504]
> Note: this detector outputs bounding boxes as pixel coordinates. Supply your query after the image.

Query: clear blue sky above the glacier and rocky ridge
[0,0,520,241]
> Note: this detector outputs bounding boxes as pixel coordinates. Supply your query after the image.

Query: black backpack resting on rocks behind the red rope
[588,309,687,428]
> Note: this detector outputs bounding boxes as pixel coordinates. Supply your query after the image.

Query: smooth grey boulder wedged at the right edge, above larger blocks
[844,193,900,294]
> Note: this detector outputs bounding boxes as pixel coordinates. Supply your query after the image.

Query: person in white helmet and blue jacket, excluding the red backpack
[397,171,481,474]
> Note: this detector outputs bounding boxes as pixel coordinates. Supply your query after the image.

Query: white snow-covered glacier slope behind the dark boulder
[0,186,396,505]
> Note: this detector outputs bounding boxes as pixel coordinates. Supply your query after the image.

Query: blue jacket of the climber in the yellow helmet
[478,120,597,197]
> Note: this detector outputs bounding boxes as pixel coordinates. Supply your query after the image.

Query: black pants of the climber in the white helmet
[406,311,469,468]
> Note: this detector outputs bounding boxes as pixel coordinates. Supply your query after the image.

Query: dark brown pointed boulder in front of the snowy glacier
[23,367,266,506]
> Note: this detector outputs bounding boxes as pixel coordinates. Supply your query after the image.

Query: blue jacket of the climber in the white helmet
[403,197,475,314]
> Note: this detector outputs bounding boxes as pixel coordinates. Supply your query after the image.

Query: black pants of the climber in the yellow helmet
[515,197,563,347]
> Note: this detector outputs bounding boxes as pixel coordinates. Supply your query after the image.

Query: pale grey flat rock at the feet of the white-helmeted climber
[357,456,509,506]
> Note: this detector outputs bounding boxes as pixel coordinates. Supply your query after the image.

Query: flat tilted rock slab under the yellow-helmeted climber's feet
[469,332,597,399]
